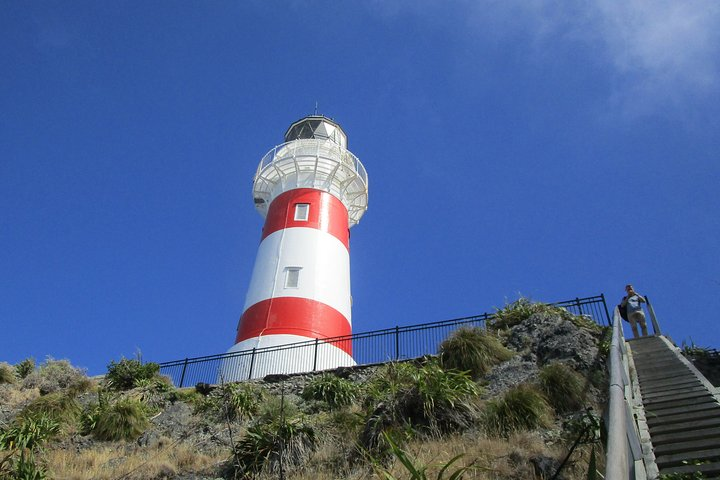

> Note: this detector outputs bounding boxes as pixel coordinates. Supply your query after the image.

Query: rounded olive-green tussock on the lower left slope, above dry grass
[91,398,149,441]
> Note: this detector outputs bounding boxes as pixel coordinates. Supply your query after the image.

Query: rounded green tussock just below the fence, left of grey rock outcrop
[440,327,513,379]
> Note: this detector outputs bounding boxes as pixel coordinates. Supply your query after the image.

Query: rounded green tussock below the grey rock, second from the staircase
[483,384,551,436]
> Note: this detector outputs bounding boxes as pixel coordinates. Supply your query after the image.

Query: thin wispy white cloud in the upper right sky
[366,0,720,116]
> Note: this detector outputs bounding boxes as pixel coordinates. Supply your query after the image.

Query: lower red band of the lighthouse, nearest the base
[235,297,352,355]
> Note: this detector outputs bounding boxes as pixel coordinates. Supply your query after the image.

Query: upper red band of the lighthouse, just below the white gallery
[262,188,350,250]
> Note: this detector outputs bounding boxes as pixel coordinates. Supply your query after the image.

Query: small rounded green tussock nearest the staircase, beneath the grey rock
[538,362,585,413]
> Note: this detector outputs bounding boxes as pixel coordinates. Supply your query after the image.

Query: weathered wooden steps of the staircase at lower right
[628,336,720,479]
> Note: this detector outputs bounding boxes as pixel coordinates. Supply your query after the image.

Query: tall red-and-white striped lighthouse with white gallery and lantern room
[219,115,368,382]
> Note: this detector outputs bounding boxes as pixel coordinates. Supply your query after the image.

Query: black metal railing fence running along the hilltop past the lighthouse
[160,294,610,387]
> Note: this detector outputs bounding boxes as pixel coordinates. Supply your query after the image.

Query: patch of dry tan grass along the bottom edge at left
[44,439,228,480]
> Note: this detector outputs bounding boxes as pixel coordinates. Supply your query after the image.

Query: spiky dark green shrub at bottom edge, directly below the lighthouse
[231,420,316,478]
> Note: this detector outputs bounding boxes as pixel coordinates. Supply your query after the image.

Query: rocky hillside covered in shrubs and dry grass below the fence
[0,299,608,480]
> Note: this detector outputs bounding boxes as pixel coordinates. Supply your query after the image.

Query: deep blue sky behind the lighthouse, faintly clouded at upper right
[0,0,720,374]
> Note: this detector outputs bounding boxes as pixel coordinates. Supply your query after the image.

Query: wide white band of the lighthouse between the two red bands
[243,227,351,324]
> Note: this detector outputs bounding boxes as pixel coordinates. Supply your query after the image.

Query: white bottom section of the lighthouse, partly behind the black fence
[218,335,355,383]
